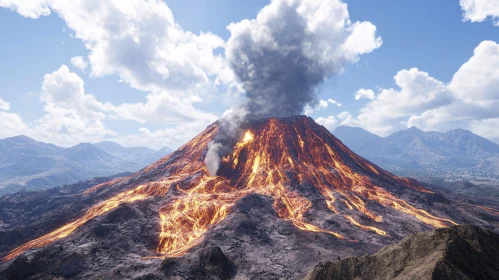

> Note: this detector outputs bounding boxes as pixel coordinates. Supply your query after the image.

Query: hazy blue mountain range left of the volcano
[0,135,171,195]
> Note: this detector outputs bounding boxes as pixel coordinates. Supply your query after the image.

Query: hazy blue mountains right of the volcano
[333,126,499,181]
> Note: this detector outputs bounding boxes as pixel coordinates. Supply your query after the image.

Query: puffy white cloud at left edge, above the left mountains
[0,65,117,146]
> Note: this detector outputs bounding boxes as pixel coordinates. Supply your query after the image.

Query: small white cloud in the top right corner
[460,0,499,25]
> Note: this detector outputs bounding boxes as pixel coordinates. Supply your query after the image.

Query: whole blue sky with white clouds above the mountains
[0,0,499,148]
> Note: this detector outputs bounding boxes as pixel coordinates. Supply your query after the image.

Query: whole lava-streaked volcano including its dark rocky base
[0,116,499,279]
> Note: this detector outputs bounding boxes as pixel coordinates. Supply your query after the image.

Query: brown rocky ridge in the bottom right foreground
[307,225,499,280]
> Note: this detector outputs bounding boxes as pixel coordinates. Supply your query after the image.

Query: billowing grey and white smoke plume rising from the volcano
[206,0,382,175]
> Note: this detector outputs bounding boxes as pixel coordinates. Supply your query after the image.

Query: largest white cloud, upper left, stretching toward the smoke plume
[0,0,236,137]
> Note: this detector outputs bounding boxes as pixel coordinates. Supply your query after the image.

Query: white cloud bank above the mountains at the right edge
[344,41,499,140]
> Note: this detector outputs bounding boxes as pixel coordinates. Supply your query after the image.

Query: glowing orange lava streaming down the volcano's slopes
[3,117,456,261]
